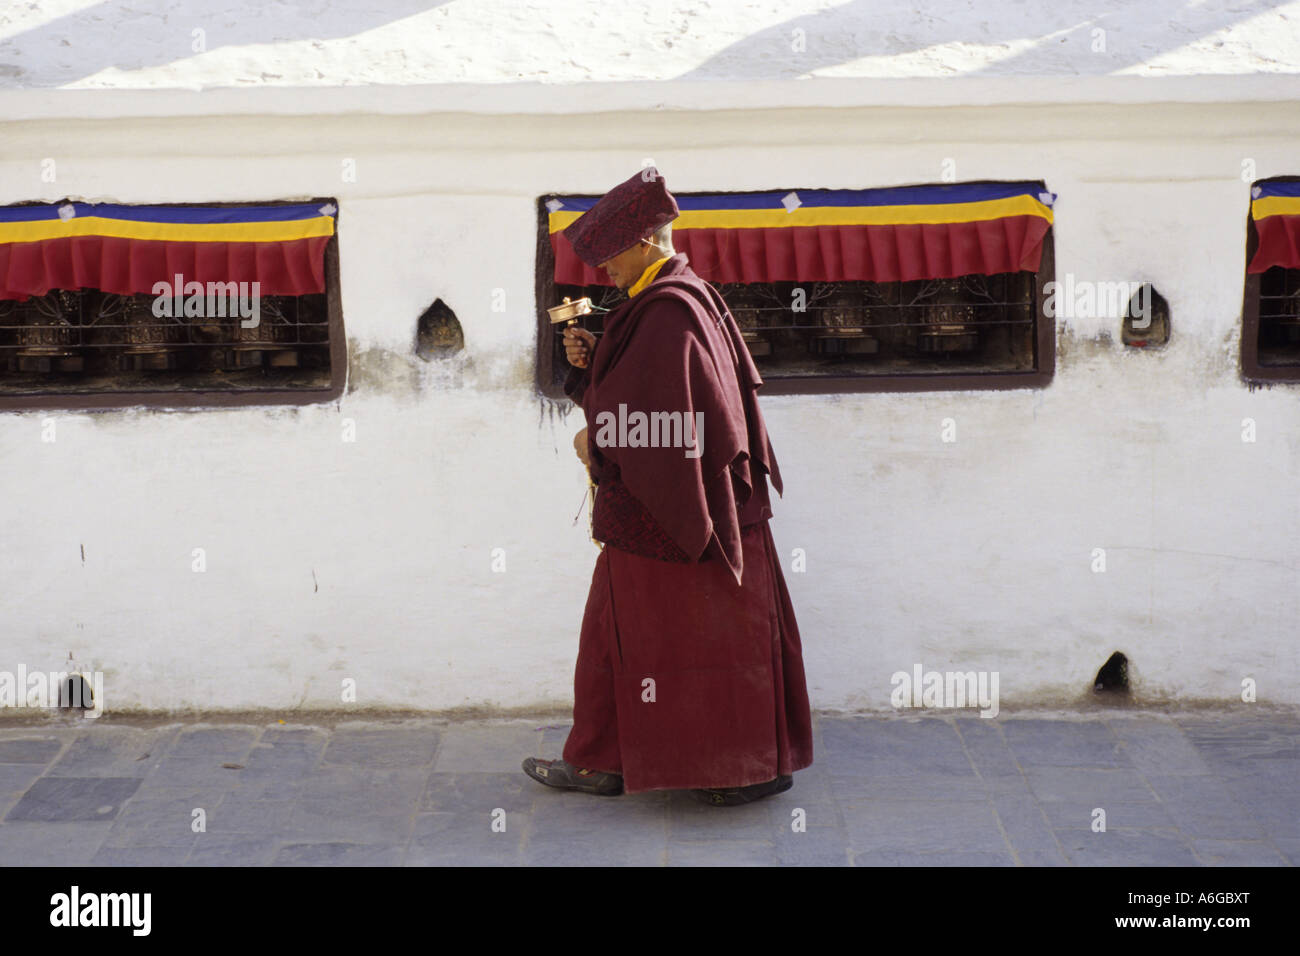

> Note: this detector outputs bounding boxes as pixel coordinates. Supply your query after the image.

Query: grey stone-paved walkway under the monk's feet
[0,709,1300,866]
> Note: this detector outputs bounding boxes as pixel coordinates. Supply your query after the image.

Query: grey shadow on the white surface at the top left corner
[0,0,449,87]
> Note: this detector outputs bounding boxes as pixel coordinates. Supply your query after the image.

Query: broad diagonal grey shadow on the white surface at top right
[677,0,1290,79]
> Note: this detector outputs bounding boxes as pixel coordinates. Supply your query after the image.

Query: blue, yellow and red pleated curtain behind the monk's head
[547,182,1056,285]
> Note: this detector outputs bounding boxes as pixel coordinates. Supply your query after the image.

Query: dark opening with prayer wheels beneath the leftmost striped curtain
[0,289,330,392]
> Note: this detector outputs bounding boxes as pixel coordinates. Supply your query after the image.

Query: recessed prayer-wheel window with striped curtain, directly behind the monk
[537,182,1054,397]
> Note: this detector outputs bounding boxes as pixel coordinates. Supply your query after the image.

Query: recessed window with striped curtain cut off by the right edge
[1242,177,1300,381]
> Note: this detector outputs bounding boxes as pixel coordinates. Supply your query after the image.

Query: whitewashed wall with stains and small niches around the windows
[0,81,1300,710]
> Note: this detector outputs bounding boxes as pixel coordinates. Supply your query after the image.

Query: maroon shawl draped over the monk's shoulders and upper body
[567,254,783,581]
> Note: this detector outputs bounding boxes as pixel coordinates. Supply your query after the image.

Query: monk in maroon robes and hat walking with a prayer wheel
[524,168,813,806]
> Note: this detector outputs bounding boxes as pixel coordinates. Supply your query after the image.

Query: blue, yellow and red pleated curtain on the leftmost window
[0,203,337,299]
